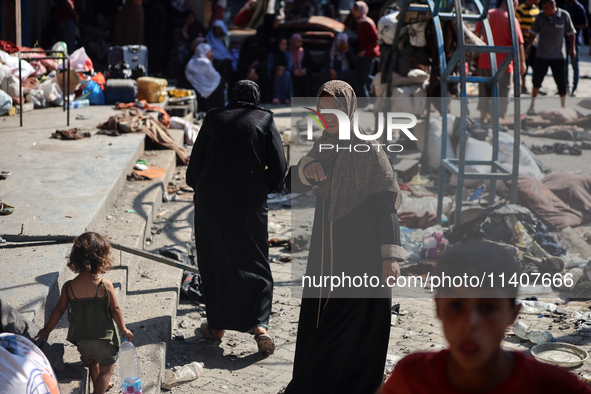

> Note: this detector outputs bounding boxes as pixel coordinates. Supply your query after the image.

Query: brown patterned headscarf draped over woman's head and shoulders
[307,80,402,220]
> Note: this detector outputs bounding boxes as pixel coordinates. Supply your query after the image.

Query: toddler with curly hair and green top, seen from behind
[35,232,133,394]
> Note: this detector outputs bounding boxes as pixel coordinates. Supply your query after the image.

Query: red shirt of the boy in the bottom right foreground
[382,349,591,394]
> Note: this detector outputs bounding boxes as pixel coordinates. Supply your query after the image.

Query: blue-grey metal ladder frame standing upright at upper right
[387,0,521,225]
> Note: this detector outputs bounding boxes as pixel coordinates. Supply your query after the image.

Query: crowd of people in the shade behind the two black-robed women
[181,1,380,111]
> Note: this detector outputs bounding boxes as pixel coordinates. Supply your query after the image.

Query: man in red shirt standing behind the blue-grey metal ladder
[476,0,526,122]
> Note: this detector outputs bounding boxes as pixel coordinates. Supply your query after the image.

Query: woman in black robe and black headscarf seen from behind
[187,80,286,353]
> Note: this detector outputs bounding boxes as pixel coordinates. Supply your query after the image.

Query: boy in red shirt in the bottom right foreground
[378,242,591,394]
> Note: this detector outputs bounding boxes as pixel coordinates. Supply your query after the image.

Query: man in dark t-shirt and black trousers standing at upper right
[525,0,577,115]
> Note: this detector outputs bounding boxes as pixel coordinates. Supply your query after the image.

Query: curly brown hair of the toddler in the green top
[68,232,113,275]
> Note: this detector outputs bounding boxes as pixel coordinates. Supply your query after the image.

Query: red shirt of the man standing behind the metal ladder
[476,8,523,73]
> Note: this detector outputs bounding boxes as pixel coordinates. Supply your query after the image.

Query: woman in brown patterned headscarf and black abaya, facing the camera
[285,81,404,394]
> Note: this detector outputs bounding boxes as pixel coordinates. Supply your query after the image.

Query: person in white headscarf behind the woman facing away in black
[185,43,227,112]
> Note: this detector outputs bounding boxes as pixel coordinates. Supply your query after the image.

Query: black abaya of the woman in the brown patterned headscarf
[285,161,400,394]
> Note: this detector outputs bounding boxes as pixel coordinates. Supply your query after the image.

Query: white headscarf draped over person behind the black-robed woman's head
[185,43,222,98]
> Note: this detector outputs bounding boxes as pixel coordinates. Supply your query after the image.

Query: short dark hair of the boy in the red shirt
[433,241,521,300]
